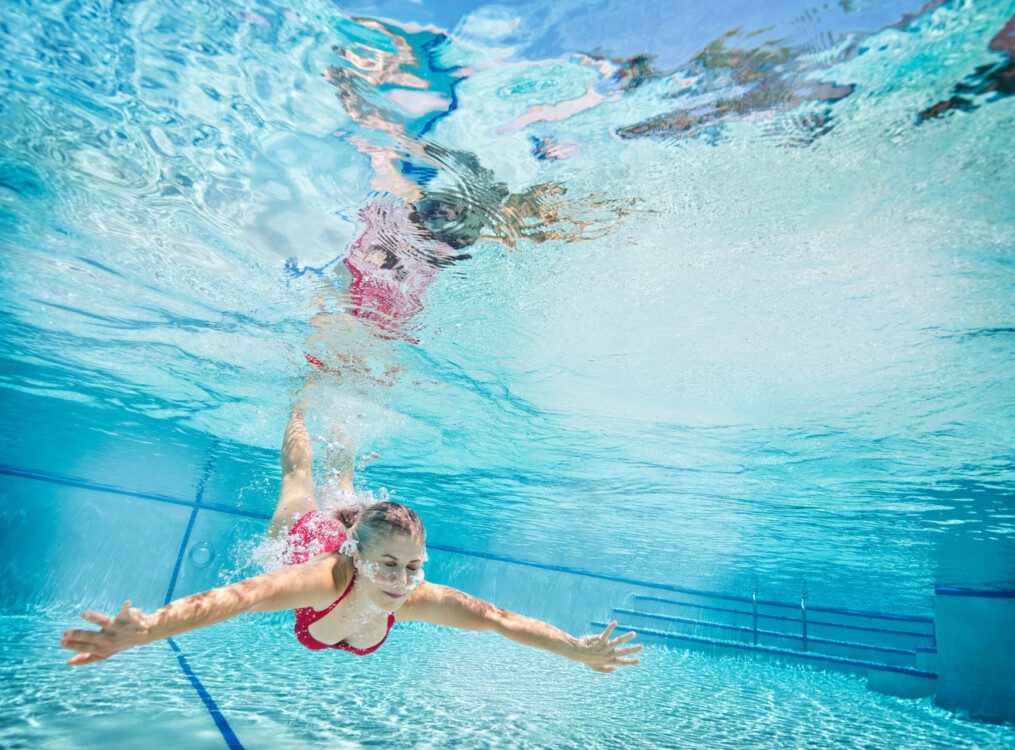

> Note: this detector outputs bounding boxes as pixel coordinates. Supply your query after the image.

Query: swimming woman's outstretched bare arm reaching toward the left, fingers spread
[60,555,335,667]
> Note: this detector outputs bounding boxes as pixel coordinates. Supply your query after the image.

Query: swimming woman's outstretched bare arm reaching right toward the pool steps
[398,583,642,672]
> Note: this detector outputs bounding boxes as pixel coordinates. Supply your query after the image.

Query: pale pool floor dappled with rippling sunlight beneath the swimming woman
[7,611,1015,750]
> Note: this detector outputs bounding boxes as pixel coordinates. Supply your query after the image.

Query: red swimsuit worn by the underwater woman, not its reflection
[282,510,395,657]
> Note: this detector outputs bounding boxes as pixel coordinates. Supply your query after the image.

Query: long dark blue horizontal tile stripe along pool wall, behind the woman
[0,464,934,623]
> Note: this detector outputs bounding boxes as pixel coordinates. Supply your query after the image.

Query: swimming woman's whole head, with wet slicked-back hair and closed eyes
[336,500,426,611]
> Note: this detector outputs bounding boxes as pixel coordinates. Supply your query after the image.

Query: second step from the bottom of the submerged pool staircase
[613,607,918,669]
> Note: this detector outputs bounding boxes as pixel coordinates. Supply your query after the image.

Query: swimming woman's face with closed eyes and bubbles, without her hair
[355,534,425,612]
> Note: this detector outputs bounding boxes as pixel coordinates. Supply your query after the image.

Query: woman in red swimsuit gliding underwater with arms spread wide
[60,408,641,672]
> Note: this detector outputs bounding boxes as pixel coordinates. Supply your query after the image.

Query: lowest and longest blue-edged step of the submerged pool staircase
[592,618,937,698]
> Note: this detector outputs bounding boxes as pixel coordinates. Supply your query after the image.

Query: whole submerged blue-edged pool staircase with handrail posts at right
[592,588,937,697]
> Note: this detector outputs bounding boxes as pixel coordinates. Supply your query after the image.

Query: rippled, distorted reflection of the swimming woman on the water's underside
[296,18,630,351]
